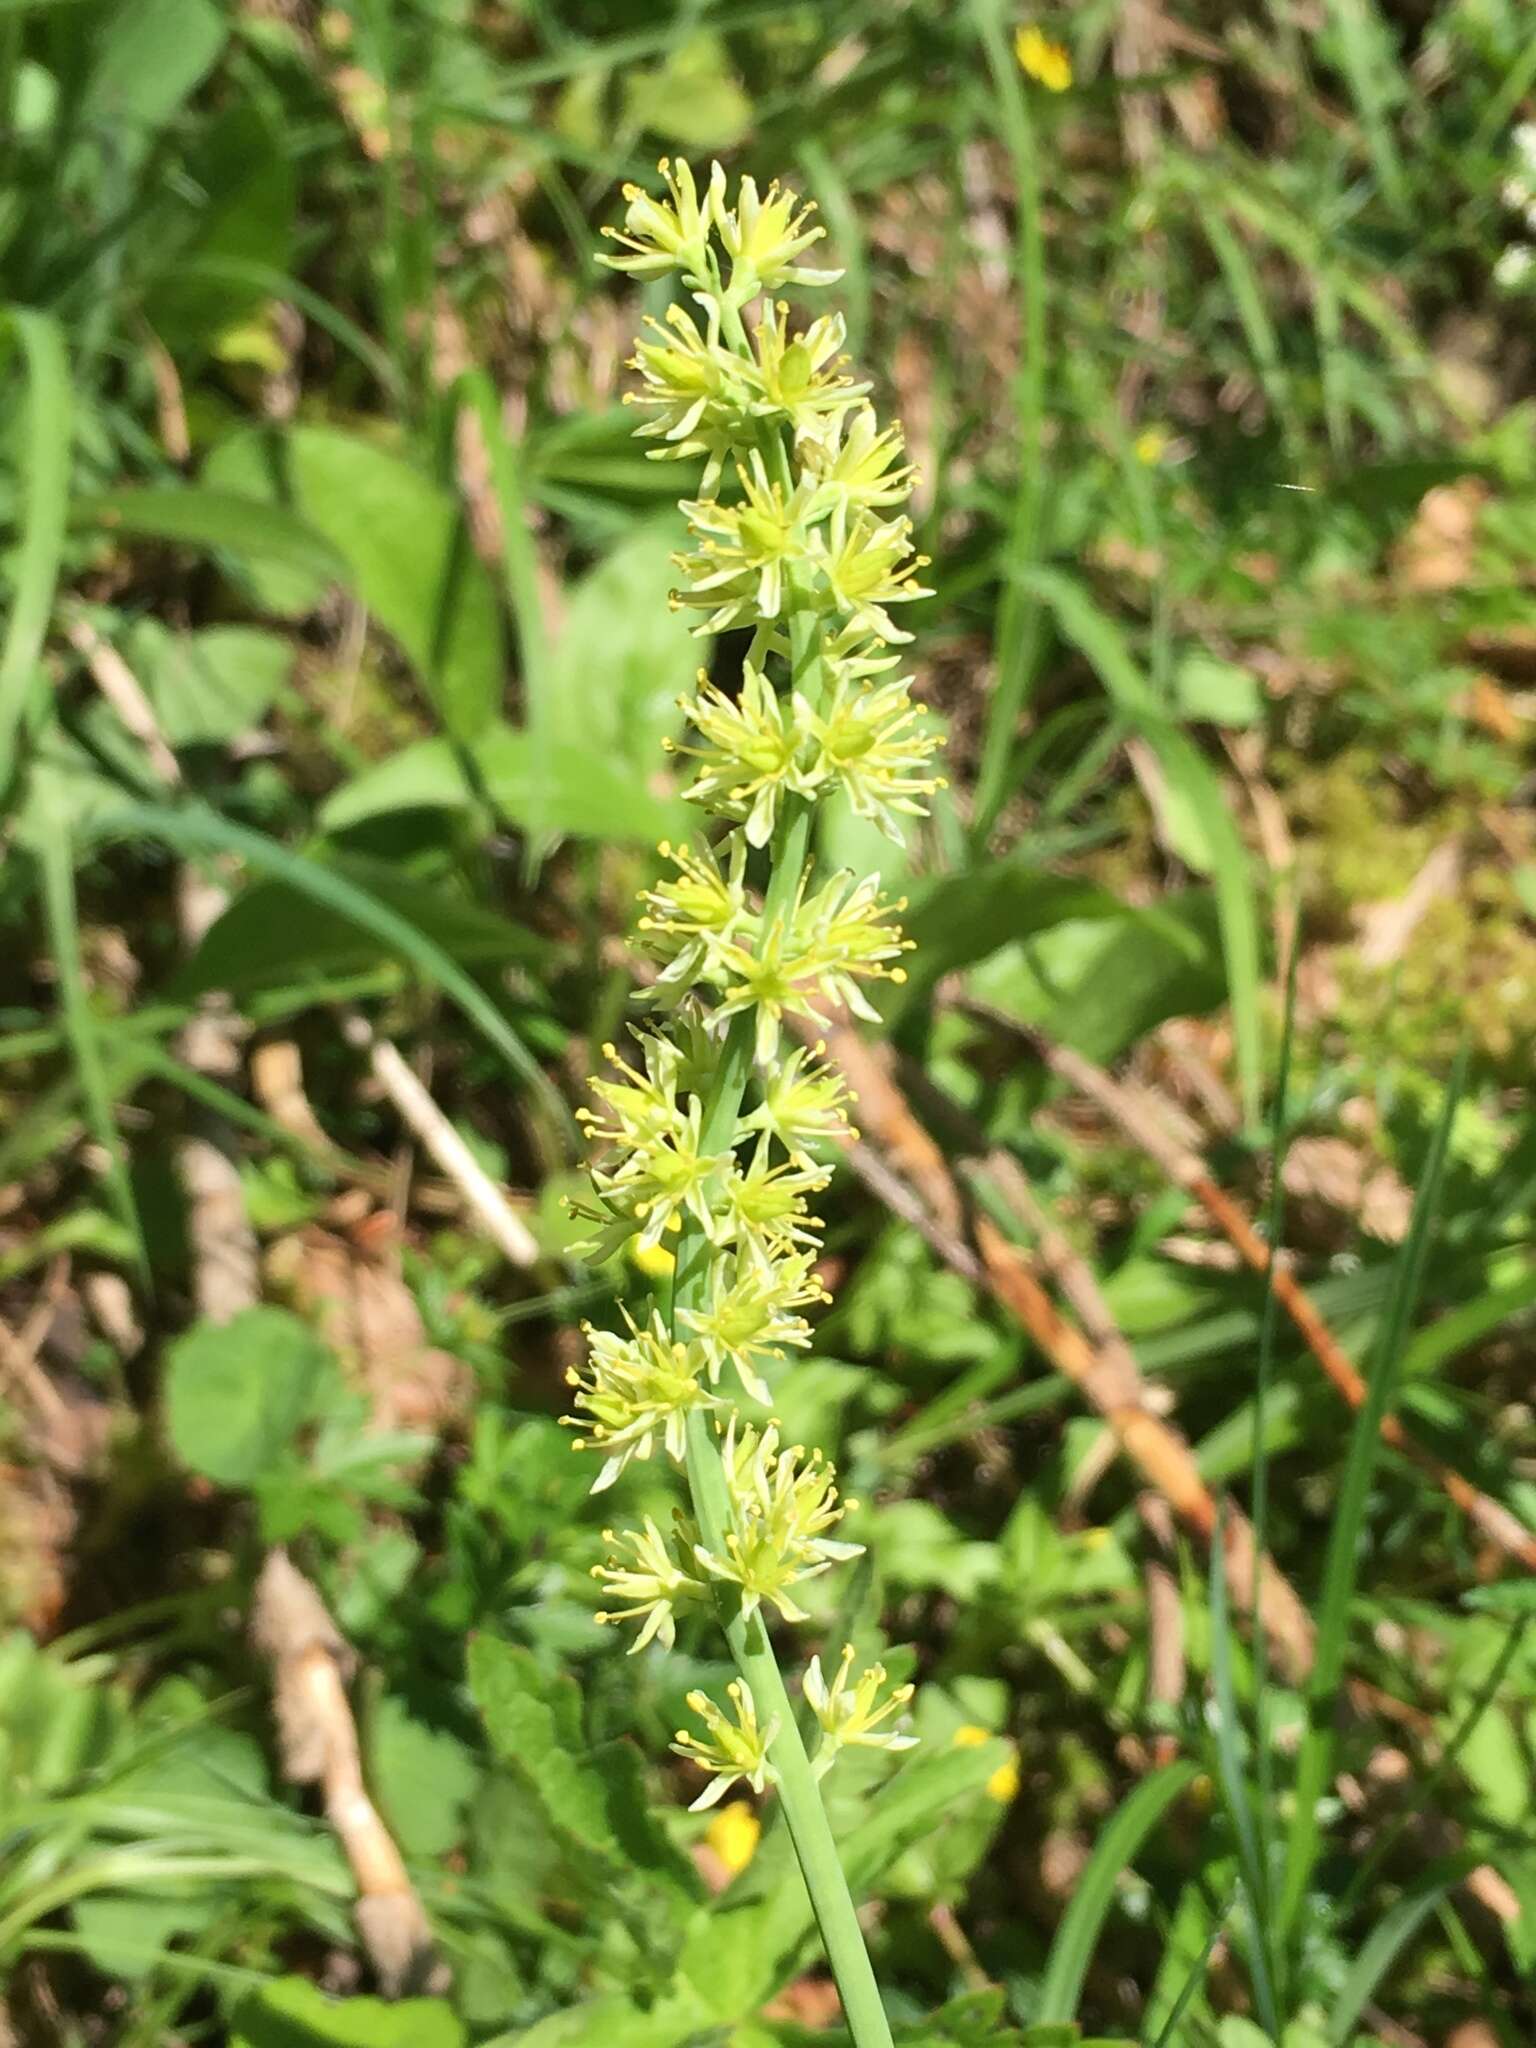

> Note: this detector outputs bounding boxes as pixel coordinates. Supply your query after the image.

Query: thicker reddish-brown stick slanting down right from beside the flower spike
[825,1024,1313,1679]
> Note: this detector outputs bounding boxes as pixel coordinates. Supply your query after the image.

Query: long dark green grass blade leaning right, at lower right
[1280,1049,1466,1937]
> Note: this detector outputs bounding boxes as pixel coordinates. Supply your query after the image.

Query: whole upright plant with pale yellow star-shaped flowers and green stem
[573,162,938,2048]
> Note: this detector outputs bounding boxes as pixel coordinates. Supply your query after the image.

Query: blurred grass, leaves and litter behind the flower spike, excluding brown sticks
[0,0,1536,2048]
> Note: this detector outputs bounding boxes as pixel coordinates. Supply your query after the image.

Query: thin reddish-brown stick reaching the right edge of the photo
[963,999,1536,1571]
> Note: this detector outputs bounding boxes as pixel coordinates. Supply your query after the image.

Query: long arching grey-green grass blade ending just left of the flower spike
[94,803,571,1130]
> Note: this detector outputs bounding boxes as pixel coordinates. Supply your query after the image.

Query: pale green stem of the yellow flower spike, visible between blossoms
[672,608,891,2048]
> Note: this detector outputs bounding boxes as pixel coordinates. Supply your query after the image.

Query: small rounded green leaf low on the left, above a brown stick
[166,1307,338,1487]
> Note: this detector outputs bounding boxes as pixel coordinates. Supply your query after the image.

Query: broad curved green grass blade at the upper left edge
[0,305,74,795]
